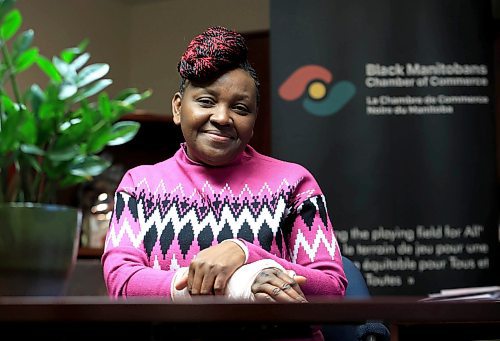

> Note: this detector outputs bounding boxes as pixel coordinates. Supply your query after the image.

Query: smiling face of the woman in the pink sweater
[172,69,257,166]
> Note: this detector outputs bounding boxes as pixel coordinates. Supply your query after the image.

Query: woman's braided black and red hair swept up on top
[177,26,260,96]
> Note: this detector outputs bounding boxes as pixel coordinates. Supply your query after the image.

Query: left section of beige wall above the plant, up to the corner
[17,0,130,101]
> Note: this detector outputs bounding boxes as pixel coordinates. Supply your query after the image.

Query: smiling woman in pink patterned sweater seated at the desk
[102,27,347,332]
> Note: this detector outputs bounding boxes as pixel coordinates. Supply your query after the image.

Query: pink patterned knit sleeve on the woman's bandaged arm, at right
[240,176,347,296]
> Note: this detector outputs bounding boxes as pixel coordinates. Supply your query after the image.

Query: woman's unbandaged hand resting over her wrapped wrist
[175,242,245,295]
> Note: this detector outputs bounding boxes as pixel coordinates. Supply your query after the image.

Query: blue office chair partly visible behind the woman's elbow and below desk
[322,256,390,341]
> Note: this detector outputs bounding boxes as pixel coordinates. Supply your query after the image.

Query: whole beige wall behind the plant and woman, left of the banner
[17,0,270,114]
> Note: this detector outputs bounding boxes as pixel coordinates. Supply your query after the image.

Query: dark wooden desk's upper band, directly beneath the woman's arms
[0,296,500,324]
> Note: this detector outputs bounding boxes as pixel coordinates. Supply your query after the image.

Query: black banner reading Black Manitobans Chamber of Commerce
[271,0,500,295]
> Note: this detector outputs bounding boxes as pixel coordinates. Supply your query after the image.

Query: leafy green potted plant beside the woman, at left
[0,0,150,203]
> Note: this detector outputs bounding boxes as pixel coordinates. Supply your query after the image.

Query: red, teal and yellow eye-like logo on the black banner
[278,64,356,116]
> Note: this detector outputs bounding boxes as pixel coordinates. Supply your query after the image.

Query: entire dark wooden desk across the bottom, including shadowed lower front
[0,297,500,340]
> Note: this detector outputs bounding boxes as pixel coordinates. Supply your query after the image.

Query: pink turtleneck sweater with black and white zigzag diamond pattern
[102,145,347,298]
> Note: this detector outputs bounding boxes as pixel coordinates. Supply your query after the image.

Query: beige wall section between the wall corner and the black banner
[129,0,269,114]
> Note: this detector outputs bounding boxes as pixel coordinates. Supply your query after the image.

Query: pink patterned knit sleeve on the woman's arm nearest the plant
[101,174,175,298]
